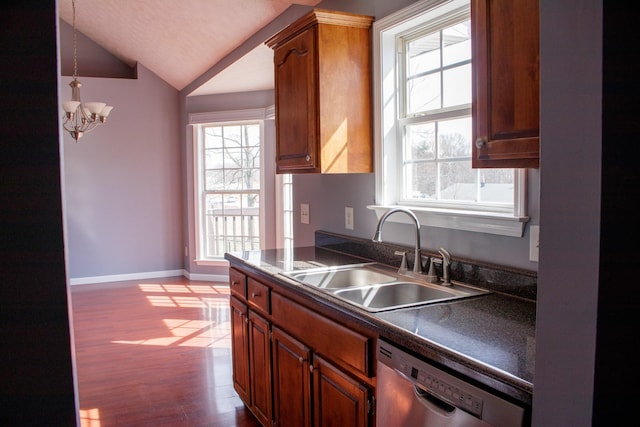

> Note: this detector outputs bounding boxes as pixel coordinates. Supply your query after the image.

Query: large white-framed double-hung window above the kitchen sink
[371,0,525,235]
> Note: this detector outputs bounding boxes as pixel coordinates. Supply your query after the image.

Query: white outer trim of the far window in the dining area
[189,108,269,266]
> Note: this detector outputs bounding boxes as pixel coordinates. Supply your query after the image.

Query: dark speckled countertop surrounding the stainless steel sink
[225,242,535,404]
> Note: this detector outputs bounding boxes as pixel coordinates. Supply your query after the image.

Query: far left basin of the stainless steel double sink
[284,263,397,289]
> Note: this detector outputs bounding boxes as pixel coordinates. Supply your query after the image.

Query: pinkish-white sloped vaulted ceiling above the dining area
[58,0,320,94]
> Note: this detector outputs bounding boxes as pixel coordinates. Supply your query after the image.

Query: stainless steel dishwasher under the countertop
[376,339,525,427]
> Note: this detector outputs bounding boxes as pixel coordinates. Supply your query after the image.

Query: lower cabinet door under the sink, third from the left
[271,326,313,427]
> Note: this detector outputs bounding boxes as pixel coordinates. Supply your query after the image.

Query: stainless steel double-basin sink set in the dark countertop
[281,262,490,312]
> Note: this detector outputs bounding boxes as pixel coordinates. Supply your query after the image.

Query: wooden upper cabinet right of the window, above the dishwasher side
[471,0,540,168]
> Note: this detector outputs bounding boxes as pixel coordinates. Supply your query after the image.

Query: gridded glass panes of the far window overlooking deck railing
[200,122,262,259]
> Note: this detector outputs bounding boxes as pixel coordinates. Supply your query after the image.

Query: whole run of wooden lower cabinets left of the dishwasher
[230,267,375,427]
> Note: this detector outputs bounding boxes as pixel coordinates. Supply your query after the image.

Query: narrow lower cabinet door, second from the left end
[249,310,272,426]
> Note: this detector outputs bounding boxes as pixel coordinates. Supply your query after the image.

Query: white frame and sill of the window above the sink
[368,0,529,237]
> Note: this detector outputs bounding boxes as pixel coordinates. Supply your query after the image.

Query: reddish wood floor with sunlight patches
[71,277,259,427]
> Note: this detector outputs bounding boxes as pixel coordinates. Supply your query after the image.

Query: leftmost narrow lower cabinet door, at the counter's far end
[230,296,251,406]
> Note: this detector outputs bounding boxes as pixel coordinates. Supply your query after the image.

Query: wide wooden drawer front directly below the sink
[271,292,373,377]
